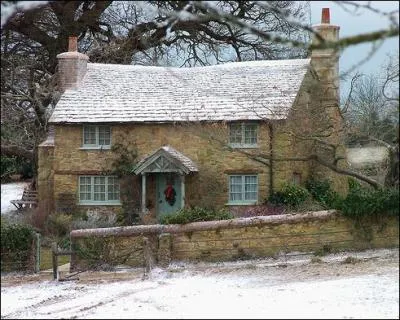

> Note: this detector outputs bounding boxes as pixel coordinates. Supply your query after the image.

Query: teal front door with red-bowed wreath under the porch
[156,173,182,219]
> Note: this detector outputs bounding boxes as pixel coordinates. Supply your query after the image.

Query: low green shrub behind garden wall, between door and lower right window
[160,207,233,224]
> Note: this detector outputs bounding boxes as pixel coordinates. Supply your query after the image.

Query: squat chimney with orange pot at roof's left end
[57,36,89,92]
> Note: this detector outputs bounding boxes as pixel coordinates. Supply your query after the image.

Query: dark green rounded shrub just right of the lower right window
[268,184,309,209]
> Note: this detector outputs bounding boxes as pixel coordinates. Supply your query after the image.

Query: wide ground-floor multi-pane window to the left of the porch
[79,176,121,205]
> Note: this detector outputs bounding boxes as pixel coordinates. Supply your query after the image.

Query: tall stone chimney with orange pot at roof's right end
[311,8,340,105]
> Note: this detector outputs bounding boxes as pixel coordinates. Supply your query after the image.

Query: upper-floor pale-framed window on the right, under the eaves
[229,122,258,148]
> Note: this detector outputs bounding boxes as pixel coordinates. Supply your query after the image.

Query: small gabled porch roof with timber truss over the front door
[133,145,199,174]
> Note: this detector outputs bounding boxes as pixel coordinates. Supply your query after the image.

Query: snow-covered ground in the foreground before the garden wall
[1,249,399,319]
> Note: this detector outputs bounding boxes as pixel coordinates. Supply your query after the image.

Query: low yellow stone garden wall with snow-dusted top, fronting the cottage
[71,210,399,269]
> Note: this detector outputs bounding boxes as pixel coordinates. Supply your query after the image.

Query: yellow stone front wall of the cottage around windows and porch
[50,119,312,223]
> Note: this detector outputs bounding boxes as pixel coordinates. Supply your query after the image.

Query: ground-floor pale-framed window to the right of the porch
[228,175,258,204]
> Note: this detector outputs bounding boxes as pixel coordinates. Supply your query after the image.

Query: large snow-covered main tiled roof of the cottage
[50,59,310,123]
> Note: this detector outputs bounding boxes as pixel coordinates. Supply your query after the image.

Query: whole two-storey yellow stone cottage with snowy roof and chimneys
[38,9,343,223]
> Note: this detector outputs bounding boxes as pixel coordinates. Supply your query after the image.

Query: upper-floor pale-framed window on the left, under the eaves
[82,125,111,149]
